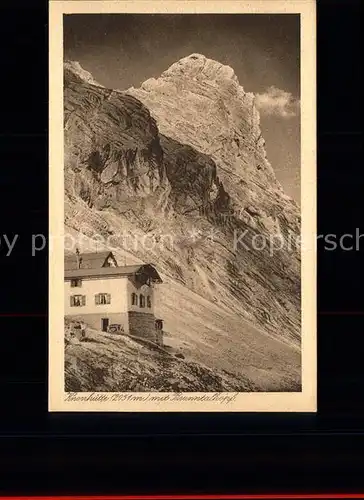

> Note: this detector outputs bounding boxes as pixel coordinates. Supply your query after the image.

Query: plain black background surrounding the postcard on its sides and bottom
[0,0,364,494]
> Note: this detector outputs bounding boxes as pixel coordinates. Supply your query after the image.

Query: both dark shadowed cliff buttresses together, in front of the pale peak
[64,63,226,219]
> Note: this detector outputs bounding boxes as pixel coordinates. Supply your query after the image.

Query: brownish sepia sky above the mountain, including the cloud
[64,14,300,203]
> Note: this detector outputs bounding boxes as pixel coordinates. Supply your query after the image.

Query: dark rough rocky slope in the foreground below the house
[65,330,300,392]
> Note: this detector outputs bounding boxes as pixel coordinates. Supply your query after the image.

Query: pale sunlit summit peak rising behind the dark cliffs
[128,54,300,240]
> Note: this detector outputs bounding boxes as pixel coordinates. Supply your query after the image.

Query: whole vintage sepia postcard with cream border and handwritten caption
[49,0,316,412]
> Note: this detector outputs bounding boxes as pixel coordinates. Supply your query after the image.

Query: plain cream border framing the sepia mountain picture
[48,0,317,412]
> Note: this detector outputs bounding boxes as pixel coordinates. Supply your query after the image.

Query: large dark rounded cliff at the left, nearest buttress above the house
[64,71,168,220]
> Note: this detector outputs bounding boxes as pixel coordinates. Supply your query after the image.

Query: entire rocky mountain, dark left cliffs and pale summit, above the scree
[64,55,300,372]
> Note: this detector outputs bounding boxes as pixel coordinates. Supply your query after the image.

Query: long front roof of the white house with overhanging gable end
[65,264,162,283]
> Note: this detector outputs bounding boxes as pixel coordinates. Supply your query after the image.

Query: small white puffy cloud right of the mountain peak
[255,86,300,118]
